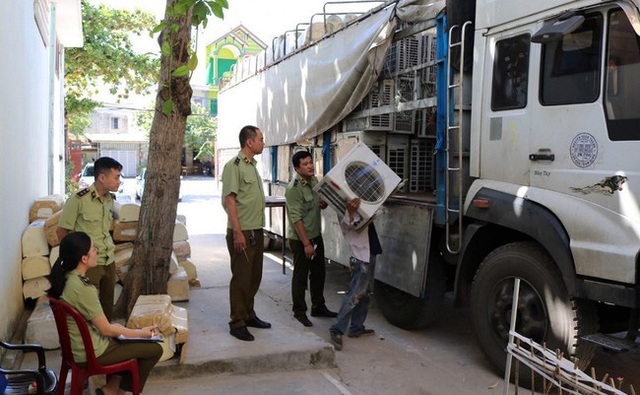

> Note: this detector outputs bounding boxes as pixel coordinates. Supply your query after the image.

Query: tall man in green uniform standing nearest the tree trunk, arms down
[222,126,271,341]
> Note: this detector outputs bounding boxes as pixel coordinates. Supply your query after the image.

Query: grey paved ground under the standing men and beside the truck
[11,177,640,395]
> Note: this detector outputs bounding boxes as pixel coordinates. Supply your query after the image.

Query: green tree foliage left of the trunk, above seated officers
[64,0,160,134]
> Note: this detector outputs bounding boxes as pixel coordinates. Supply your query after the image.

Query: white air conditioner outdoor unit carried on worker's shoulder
[314,143,401,229]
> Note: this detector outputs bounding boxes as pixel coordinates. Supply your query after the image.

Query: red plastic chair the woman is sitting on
[49,297,140,395]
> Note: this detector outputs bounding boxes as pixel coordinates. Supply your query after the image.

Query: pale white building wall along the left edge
[0,1,64,339]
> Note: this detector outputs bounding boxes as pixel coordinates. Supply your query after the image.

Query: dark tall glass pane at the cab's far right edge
[604,9,640,141]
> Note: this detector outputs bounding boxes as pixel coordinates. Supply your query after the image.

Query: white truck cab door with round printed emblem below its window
[529,12,607,193]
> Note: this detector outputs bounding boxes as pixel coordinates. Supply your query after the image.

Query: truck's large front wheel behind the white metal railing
[471,242,598,388]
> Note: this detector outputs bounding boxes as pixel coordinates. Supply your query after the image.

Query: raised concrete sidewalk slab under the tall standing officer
[152,287,334,378]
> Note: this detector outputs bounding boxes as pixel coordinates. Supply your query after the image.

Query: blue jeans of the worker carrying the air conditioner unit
[329,255,376,335]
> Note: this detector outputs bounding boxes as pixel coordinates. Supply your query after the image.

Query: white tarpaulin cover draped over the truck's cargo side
[218,0,444,148]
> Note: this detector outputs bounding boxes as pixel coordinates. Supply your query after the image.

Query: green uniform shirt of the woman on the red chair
[60,270,109,363]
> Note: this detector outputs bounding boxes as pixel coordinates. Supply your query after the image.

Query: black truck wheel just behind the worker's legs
[373,257,446,329]
